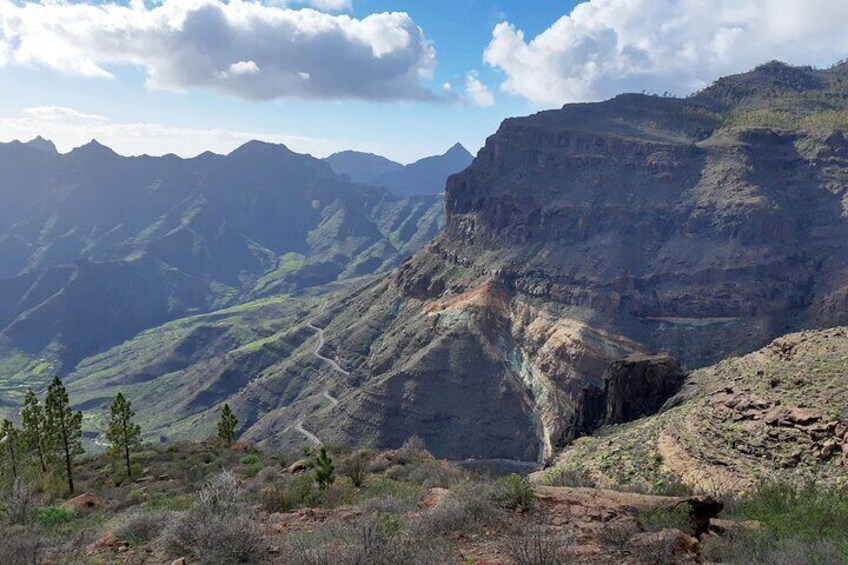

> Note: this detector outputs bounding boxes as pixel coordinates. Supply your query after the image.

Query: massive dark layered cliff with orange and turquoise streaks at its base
[234,63,848,459]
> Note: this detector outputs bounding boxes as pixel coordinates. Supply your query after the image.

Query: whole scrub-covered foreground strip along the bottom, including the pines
[0,382,848,565]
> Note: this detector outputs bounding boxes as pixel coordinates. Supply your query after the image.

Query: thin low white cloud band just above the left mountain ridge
[0,106,334,157]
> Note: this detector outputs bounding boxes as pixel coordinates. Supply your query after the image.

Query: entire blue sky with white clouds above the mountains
[0,0,848,162]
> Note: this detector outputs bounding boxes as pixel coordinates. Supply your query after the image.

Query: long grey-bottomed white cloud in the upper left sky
[0,0,436,101]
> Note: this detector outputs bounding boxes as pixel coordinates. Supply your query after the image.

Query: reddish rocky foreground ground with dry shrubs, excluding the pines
[0,442,784,565]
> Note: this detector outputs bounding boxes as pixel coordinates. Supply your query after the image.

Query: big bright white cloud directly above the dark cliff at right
[484,0,848,105]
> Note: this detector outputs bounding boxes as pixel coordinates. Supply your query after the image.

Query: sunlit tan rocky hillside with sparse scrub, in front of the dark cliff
[557,327,848,492]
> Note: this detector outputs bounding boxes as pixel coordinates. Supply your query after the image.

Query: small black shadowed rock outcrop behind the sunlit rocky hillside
[604,355,686,424]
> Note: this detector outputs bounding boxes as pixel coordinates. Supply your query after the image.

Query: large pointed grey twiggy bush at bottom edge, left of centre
[162,471,265,565]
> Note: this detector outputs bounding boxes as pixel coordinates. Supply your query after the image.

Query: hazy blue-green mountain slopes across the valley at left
[0,139,443,370]
